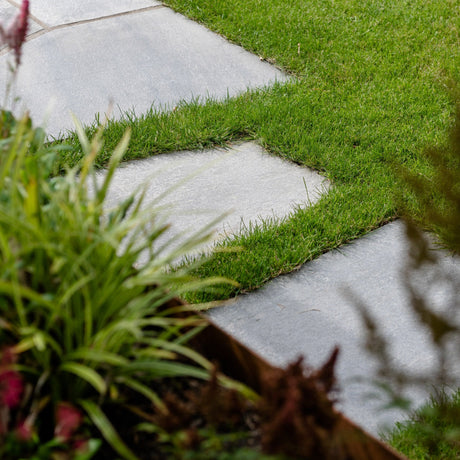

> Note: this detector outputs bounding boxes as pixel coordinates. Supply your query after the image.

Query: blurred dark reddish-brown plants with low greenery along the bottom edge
[146,348,344,460]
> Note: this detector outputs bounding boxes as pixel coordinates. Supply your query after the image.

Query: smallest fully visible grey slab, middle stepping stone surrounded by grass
[95,142,329,263]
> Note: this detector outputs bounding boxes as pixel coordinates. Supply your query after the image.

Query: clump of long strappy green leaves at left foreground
[0,112,249,459]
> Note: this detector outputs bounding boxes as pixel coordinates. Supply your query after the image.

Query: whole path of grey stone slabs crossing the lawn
[0,0,460,433]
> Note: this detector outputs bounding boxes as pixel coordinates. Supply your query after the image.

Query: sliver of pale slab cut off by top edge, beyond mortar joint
[26,0,161,26]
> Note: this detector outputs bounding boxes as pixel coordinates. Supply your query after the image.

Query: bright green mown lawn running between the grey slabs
[58,0,460,301]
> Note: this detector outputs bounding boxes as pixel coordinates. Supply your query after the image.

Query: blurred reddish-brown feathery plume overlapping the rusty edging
[258,348,342,460]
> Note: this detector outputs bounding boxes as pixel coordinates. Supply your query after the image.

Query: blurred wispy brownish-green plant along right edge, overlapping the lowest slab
[357,90,460,458]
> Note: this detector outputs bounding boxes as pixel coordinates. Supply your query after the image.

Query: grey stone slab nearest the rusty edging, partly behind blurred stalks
[209,222,460,433]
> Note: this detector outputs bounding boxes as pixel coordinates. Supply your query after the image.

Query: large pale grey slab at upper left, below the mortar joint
[0,8,287,135]
